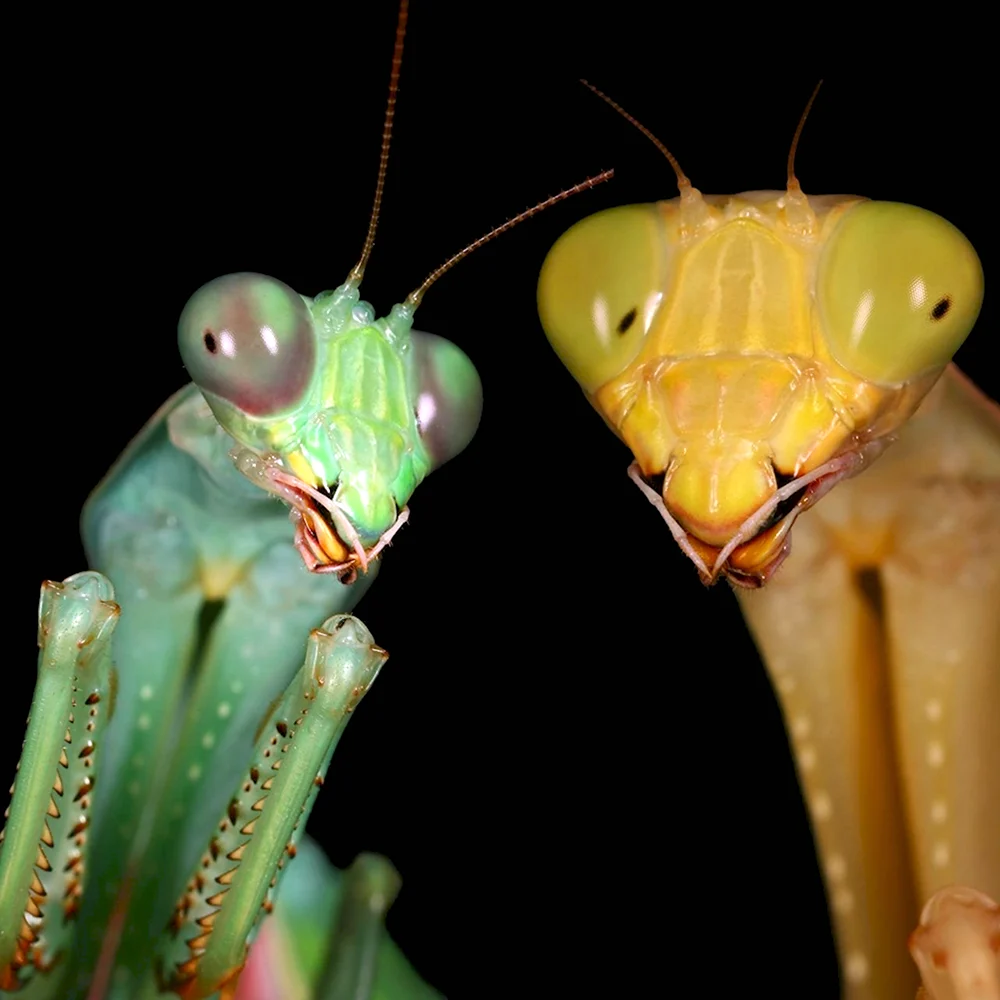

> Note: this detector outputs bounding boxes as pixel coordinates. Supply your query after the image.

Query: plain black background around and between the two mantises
[3,9,998,1000]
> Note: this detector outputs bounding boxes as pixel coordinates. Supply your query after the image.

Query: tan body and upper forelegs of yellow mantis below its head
[739,368,1000,1000]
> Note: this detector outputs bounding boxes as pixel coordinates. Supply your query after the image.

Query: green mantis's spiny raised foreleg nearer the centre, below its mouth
[157,615,386,1000]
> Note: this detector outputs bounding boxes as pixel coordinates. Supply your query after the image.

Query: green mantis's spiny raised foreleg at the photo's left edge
[0,573,119,996]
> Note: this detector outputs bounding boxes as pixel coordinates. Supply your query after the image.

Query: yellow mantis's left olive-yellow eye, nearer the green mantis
[538,205,667,392]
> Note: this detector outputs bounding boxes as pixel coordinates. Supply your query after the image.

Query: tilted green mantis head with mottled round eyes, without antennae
[178,274,482,574]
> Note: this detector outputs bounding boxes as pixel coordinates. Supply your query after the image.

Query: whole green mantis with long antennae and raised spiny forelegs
[0,2,611,1000]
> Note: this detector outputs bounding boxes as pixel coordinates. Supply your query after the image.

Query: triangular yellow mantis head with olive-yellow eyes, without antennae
[538,189,983,587]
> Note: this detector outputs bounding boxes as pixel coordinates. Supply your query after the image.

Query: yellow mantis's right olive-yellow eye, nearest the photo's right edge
[817,201,983,384]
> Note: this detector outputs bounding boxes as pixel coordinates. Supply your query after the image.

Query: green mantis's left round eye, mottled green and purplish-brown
[178,274,316,417]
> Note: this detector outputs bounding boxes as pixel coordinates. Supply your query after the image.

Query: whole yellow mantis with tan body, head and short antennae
[538,88,1000,1000]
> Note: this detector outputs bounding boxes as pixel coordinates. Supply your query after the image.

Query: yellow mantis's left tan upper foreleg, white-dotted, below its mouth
[739,528,918,1000]
